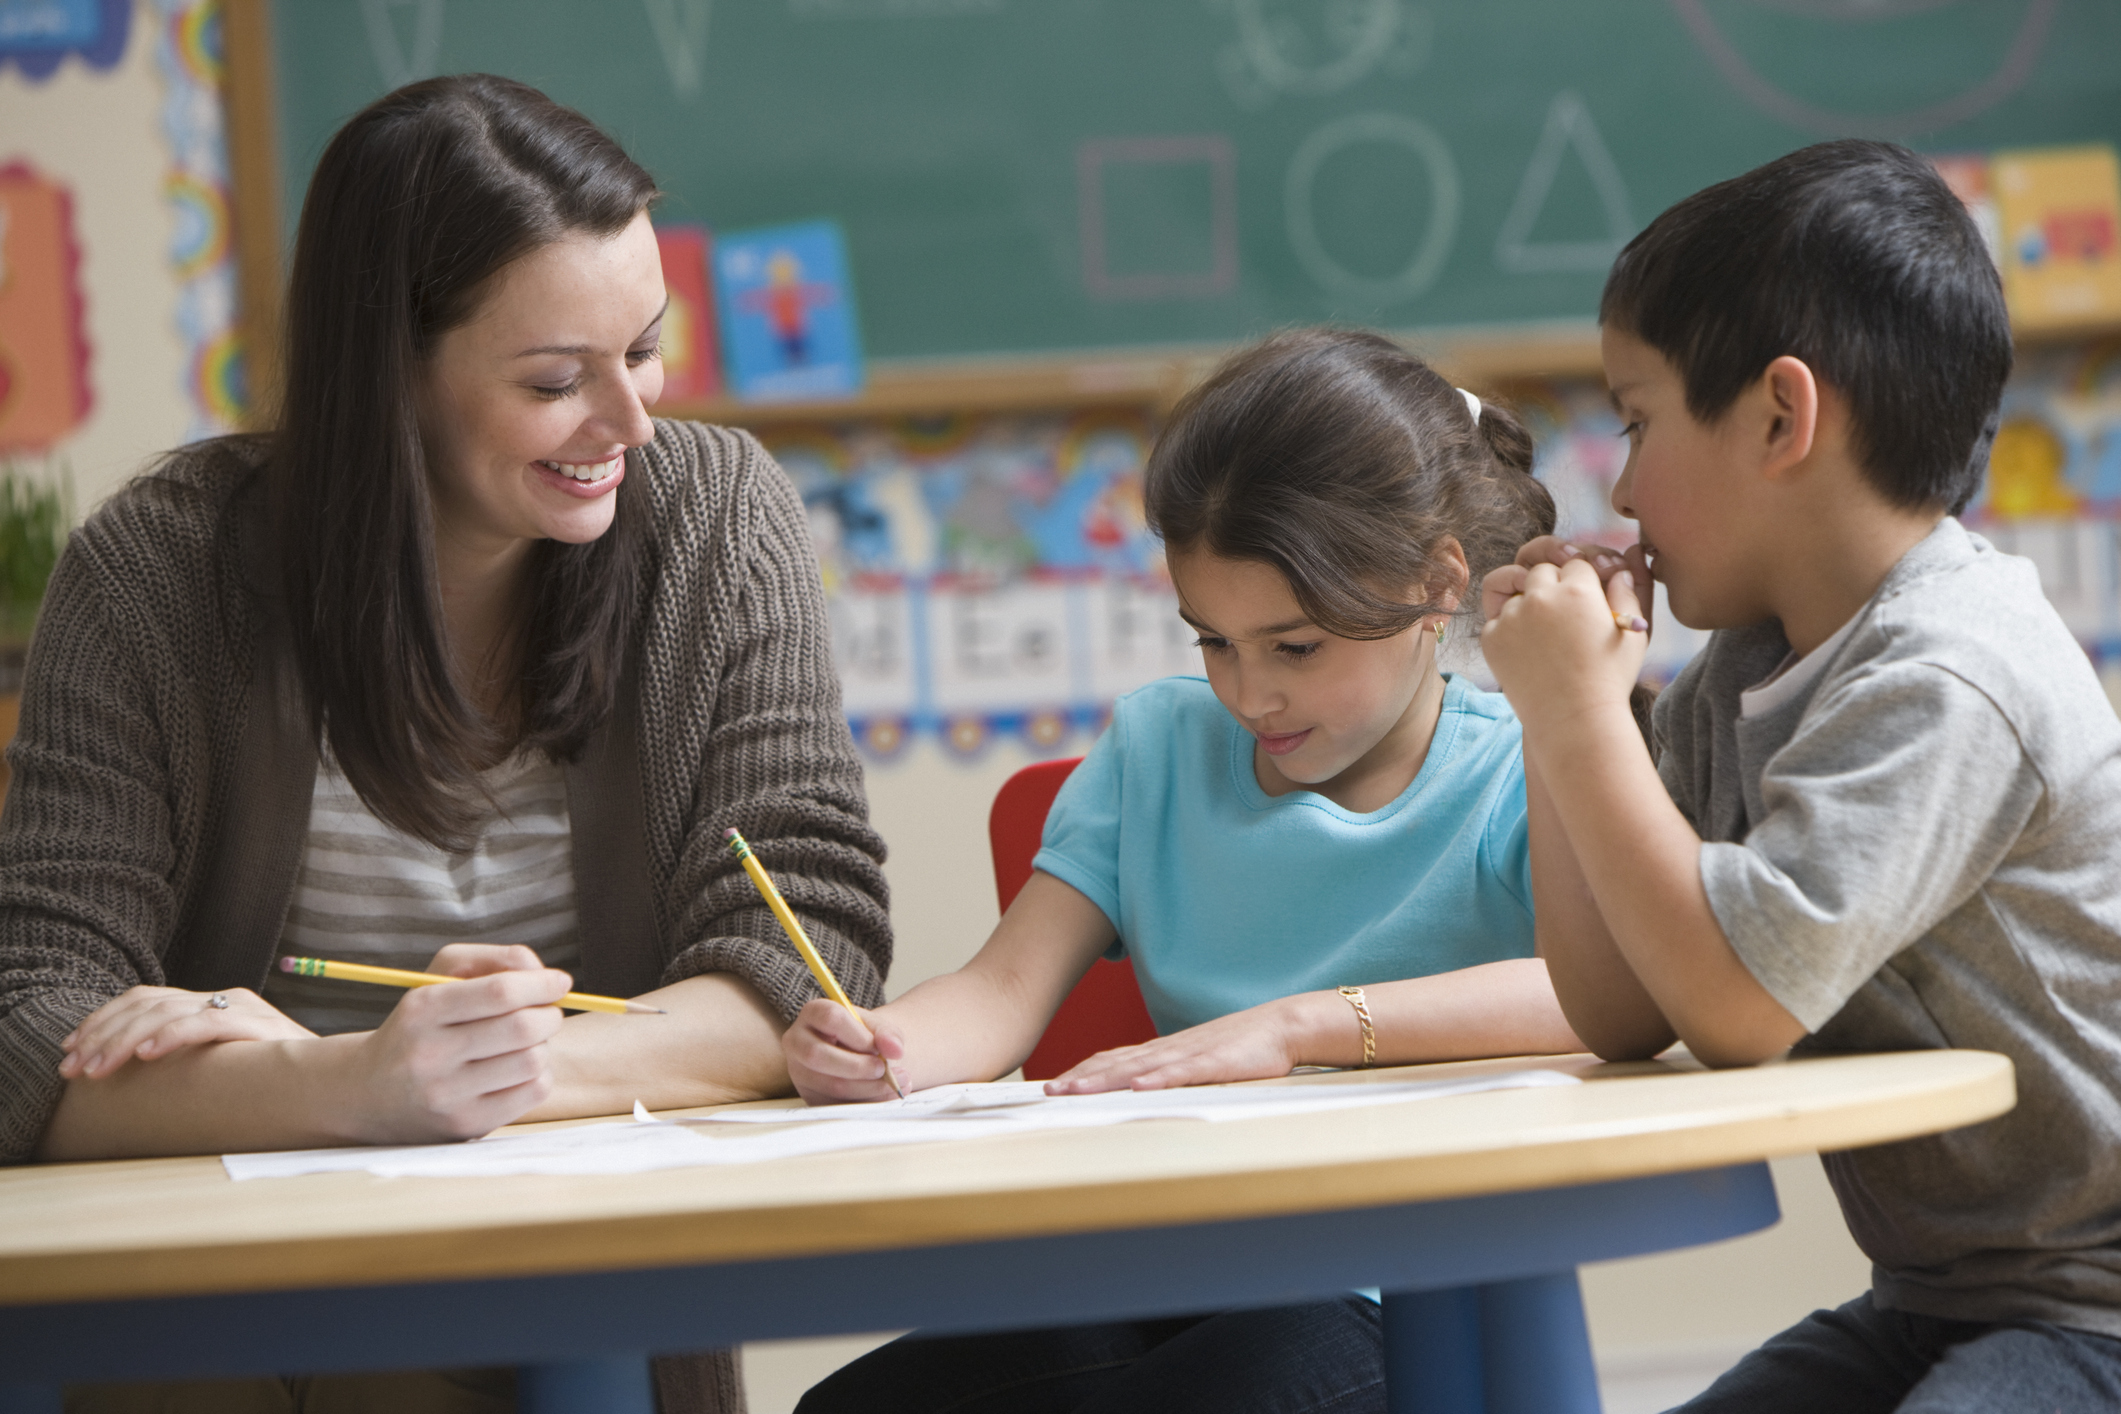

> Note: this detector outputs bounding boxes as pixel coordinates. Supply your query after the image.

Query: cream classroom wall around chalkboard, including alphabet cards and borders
[12,0,2121,1414]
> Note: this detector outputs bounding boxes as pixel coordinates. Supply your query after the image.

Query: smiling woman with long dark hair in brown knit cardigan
[0,76,891,1395]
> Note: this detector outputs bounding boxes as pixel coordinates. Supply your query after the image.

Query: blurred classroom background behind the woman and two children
[0,0,2121,1414]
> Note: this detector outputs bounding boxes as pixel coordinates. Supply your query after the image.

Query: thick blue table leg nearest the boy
[1385,1272,1599,1414]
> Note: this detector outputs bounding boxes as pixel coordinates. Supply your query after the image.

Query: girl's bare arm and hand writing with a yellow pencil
[781,871,1111,1104]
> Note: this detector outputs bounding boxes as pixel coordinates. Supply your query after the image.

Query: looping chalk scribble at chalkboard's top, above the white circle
[1215,0,1436,108]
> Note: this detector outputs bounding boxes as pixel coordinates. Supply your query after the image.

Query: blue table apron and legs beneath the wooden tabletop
[0,1164,1780,1414]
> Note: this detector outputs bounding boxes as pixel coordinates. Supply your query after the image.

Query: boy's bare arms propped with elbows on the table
[1483,562,1805,1064]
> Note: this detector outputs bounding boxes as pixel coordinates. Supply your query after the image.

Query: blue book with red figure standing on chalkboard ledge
[715,220,861,401]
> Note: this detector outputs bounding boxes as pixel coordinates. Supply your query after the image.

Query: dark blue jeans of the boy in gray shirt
[1680,1293,2121,1414]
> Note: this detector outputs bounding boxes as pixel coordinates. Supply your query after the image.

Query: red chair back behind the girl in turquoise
[986,757,1156,1081]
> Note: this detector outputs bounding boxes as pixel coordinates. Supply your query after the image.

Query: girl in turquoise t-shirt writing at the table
[783,331,1582,1414]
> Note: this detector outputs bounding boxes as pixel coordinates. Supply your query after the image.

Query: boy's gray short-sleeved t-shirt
[1657,519,2121,1336]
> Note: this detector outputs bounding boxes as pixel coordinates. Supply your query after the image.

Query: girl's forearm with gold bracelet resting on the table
[1279,958,1584,1066]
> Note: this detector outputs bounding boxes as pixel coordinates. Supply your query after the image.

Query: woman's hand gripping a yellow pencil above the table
[348,943,575,1143]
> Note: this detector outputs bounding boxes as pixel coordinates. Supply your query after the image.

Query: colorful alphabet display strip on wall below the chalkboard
[764,339,2121,759]
